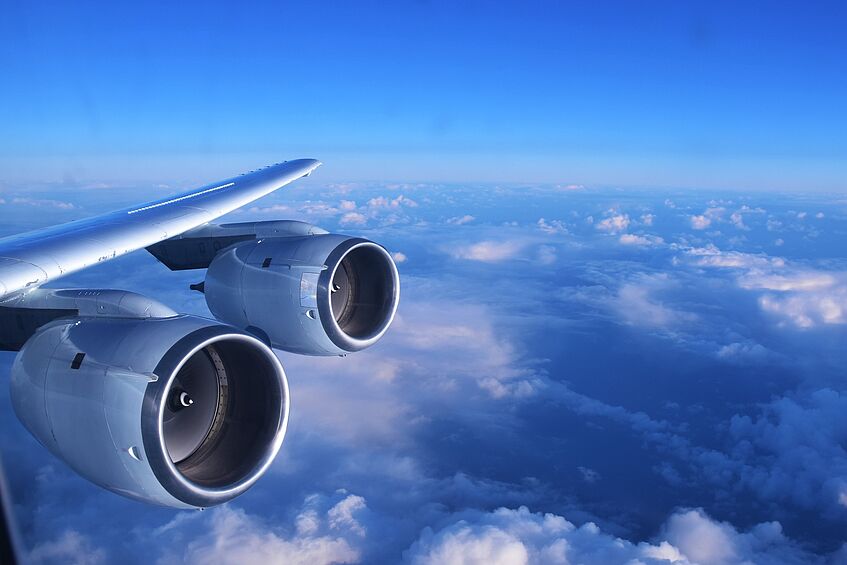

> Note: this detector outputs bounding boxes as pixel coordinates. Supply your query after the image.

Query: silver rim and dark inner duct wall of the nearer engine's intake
[141,325,290,508]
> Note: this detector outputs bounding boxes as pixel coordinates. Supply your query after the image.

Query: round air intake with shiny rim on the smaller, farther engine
[317,238,400,352]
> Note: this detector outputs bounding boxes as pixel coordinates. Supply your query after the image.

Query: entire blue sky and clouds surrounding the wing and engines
[0,1,847,565]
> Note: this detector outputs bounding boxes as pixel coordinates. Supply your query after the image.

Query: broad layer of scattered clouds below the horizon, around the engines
[2,181,847,564]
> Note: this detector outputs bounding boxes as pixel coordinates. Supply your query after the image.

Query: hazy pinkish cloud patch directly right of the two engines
[283,298,544,456]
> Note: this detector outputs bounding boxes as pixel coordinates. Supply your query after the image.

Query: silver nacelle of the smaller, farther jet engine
[204,234,400,355]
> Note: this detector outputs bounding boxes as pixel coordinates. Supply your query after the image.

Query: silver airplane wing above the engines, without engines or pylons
[0,159,321,298]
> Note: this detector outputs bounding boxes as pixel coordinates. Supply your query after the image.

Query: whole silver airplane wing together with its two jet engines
[0,159,400,508]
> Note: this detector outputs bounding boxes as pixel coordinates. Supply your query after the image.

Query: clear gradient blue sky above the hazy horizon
[0,0,847,191]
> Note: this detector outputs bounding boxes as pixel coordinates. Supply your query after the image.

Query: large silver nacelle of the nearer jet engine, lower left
[11,316,289,508]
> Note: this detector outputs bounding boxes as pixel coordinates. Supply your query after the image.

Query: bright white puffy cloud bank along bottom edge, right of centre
[404,506,820,565]
